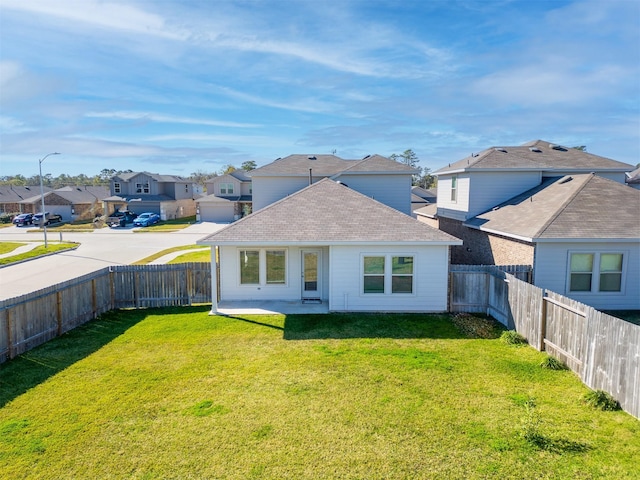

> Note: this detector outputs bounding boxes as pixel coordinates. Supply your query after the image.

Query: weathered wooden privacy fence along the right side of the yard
[450,265,640,418]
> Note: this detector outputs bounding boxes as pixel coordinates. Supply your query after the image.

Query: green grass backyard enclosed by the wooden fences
[0,307,640,479]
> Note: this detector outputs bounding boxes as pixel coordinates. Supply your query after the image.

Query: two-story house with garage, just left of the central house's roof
[196,170,252,223]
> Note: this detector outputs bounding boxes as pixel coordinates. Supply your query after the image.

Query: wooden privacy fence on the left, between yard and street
[0,263,211,363]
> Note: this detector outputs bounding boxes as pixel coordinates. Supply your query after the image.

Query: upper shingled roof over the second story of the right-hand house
[434,140,633,175]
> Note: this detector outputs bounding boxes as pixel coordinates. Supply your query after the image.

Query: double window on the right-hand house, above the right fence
[569,252,624,292]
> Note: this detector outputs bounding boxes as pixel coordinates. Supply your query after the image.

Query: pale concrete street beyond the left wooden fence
[0,222,224,300]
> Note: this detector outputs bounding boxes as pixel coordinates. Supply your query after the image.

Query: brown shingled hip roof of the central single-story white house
[198,179,462,245]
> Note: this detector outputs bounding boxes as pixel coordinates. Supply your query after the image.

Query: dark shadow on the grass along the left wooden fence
[0,306,208,408]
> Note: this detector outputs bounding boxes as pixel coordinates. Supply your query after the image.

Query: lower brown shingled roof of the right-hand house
[464,174,640,241]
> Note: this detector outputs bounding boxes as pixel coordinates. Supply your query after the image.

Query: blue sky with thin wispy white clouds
[0,0,640,176]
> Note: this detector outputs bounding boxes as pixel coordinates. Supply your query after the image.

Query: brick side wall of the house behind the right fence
[438,217,534,265]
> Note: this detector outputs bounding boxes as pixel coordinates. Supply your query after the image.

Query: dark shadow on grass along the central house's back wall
[284,313,468,340]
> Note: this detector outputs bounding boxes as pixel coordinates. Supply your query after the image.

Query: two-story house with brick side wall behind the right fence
[416,140,640,309]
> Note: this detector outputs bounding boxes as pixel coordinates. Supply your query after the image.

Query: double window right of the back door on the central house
[363,255,414,294]
